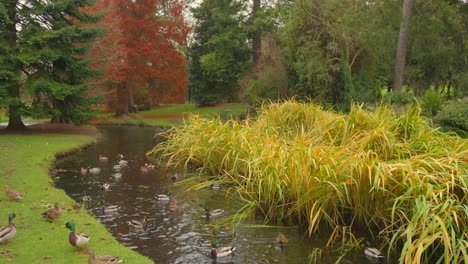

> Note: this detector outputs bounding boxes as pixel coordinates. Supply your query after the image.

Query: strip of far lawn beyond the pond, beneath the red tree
[92,104,248,127]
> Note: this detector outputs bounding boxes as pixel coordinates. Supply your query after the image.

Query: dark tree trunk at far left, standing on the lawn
[2,0,26,130]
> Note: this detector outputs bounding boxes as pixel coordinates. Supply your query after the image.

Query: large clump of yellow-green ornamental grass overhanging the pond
[152,101,468,263]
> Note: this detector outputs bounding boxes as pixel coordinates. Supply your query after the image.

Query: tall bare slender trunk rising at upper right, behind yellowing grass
[393,0,413,92]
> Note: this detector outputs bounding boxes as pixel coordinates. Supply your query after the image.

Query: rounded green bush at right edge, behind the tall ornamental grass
[435,97,468,136]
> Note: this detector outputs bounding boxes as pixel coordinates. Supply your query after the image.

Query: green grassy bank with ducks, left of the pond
[0,134,153,263]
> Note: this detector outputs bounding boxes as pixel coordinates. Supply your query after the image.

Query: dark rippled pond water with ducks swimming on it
[52,127,384,264]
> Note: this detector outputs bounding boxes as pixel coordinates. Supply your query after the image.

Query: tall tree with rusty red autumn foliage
[89,0,190,116]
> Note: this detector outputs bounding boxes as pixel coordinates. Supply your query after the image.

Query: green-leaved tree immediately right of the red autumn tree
[189,0,251,106]
